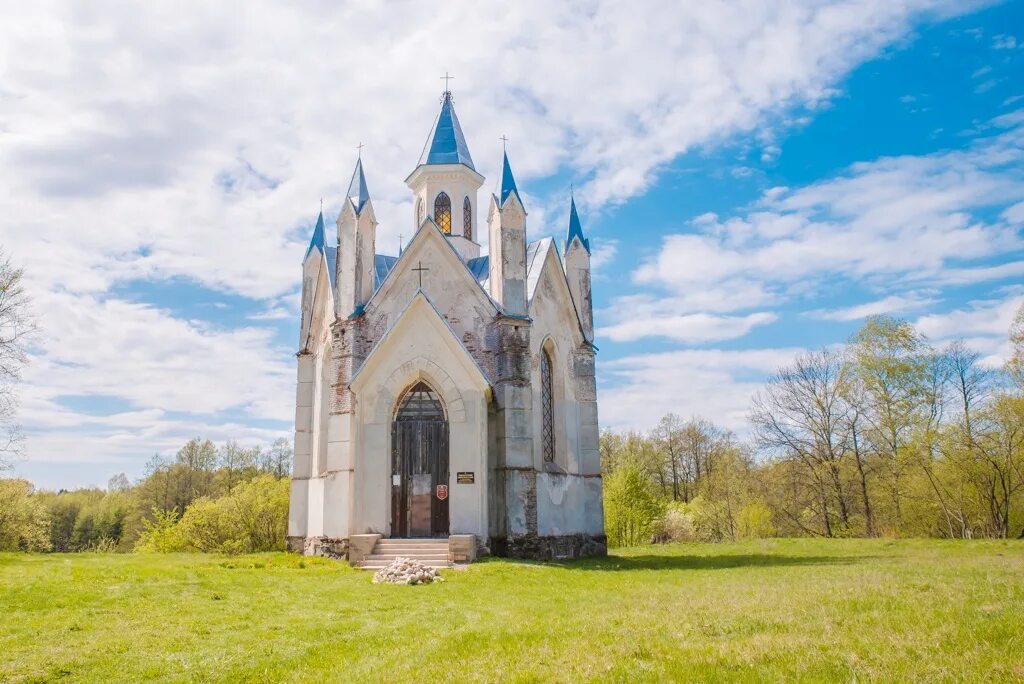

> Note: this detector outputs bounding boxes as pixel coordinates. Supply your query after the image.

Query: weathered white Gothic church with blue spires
[289,91,605,558]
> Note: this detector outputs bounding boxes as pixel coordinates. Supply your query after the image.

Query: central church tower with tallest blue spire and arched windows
[406,90,483,261]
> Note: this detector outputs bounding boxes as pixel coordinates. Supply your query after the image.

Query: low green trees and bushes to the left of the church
[0,438,292,553]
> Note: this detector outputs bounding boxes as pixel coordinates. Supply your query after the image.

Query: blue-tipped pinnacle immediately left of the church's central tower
[335,157,377,317]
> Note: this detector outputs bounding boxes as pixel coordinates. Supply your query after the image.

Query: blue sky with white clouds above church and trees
[0,0,1024,488]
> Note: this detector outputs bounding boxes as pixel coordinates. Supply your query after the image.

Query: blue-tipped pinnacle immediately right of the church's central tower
[487,154,526,315]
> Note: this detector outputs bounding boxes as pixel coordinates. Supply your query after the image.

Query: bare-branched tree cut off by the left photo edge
[0,251,36,469]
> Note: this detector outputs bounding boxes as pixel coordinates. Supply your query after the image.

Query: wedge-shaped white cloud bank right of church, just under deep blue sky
[635,120,1024,305]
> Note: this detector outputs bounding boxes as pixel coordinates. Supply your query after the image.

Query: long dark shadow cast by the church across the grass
[564,553,862,571]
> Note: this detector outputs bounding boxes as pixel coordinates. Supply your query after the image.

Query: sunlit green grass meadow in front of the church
[0,540,1024,682]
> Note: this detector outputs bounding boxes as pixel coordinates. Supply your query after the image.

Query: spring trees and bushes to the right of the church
[601,307,1024,545]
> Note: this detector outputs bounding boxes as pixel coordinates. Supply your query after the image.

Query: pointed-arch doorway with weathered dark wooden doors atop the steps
[391,382,449,537]
